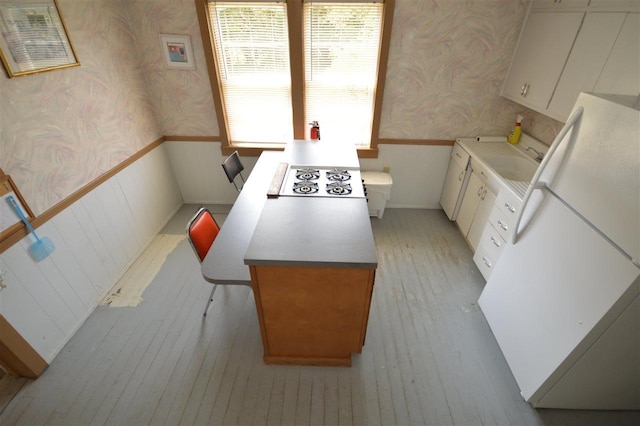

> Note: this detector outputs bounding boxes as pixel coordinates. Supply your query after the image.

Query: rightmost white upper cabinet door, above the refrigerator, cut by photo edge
[593,13,640,95]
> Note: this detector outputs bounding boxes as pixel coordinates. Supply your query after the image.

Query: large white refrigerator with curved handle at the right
[479,93,640,409]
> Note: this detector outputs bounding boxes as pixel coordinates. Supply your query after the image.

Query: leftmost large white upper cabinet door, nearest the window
[502,12,584,112]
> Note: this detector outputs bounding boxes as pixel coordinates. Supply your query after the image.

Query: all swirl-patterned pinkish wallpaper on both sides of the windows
[0,0,561,214]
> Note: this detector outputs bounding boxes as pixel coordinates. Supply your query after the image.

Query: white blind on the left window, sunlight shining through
[209,2,293,143]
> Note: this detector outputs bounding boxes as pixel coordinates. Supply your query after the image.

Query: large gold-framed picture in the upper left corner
[0,0,80,78]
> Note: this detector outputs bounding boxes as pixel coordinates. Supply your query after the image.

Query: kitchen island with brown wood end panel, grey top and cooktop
[236,141,377,366]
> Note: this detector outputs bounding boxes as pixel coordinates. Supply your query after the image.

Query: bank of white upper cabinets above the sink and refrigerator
[502,0,640,122]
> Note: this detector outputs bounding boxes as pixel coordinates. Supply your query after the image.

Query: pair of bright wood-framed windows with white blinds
[207,0,393,147]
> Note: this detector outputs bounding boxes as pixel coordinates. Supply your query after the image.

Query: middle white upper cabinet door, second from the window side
[548,13,624,122]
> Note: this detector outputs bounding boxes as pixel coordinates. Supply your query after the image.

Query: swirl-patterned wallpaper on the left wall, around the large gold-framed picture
[0,0,162,214]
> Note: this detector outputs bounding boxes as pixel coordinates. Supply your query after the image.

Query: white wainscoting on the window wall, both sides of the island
[164,142,452,209]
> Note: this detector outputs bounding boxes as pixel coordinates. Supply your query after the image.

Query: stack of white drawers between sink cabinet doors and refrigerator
[473,189,522,280]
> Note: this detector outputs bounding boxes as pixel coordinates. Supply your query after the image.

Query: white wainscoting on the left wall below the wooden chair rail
[0,144,182,363]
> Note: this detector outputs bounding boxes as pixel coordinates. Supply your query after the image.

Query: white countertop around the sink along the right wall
[458,135,539,200]
